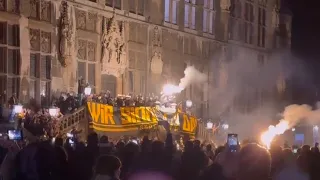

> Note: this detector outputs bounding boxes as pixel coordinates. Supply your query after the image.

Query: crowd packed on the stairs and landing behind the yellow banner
[0,91,174,137]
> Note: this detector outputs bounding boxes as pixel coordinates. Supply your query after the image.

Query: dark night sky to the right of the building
[286,0,320,104]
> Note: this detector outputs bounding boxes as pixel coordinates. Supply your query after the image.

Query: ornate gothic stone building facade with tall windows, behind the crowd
[0,0,291,116]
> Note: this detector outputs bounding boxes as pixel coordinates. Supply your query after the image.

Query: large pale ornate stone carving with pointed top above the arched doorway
[102,15,128,77]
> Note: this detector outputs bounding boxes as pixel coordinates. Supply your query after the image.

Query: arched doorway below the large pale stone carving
[101,74,117,97]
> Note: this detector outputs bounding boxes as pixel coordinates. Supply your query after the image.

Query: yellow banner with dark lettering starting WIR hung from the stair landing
[87,102,198,134]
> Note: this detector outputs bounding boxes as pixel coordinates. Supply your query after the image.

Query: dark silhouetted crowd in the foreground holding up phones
[0,133,320,180]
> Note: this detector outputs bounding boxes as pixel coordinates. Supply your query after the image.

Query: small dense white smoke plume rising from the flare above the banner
[179,66,207,89]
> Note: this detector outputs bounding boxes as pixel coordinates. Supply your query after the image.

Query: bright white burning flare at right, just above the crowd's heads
[261,120,289,149]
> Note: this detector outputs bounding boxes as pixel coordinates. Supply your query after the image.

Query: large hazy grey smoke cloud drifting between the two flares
[207,47,307,141]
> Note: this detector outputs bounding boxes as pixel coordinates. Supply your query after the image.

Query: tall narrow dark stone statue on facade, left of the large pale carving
[59,1,73,67]
